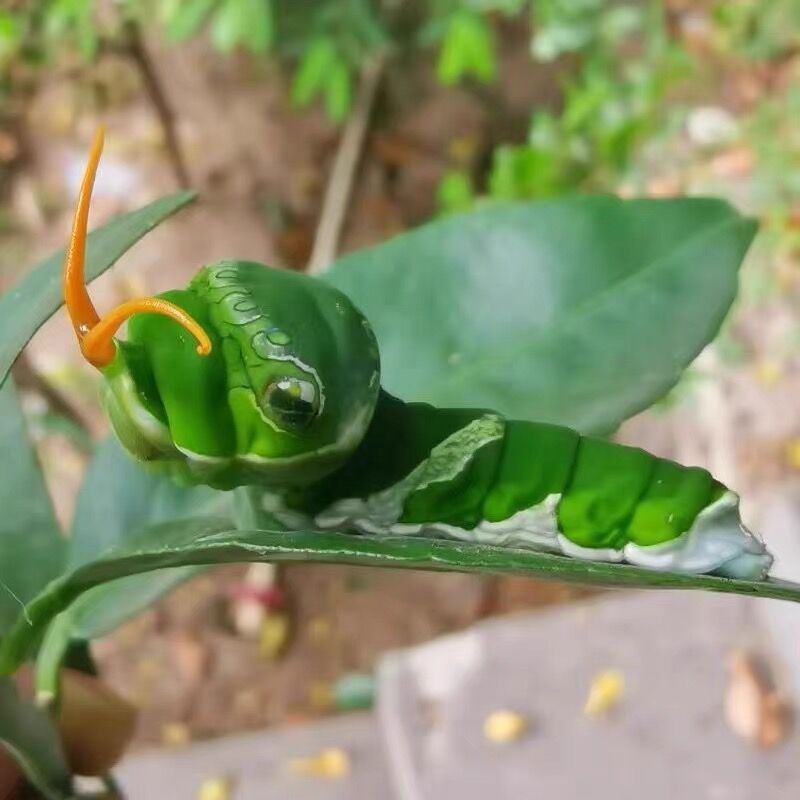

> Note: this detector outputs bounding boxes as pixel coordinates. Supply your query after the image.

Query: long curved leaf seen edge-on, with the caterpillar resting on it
[0,518,800,673]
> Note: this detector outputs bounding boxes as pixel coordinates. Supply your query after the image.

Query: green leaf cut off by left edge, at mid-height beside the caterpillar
[0,380,65,636]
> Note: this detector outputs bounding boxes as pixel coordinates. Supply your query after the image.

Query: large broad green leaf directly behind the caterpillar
[325,197,756,433]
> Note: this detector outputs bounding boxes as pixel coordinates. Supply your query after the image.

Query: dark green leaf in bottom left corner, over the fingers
[0,678,74,800]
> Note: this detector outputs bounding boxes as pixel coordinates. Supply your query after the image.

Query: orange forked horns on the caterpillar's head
[64,127,211,367]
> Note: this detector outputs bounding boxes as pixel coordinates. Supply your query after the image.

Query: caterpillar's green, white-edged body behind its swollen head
[284,393,772,579]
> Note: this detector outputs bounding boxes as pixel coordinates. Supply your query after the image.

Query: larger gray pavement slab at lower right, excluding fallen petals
[379,592,800,800]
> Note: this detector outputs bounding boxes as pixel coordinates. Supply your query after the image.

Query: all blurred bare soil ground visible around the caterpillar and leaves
[0,10,800,744]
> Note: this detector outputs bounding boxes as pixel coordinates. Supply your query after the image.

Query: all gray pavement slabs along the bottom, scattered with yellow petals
[117,584,800,800]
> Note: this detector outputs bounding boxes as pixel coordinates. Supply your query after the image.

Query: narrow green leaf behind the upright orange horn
[0,192,195,385]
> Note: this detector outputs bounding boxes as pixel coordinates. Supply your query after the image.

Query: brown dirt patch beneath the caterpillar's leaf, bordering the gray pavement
[93,565,586,745]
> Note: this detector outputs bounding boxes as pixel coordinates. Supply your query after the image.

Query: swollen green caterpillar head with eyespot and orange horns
[64,131,379,489]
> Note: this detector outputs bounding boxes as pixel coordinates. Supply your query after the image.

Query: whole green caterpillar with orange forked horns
[64,130,772,579]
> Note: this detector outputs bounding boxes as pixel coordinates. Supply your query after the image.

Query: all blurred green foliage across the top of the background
[0,0,800,366]
